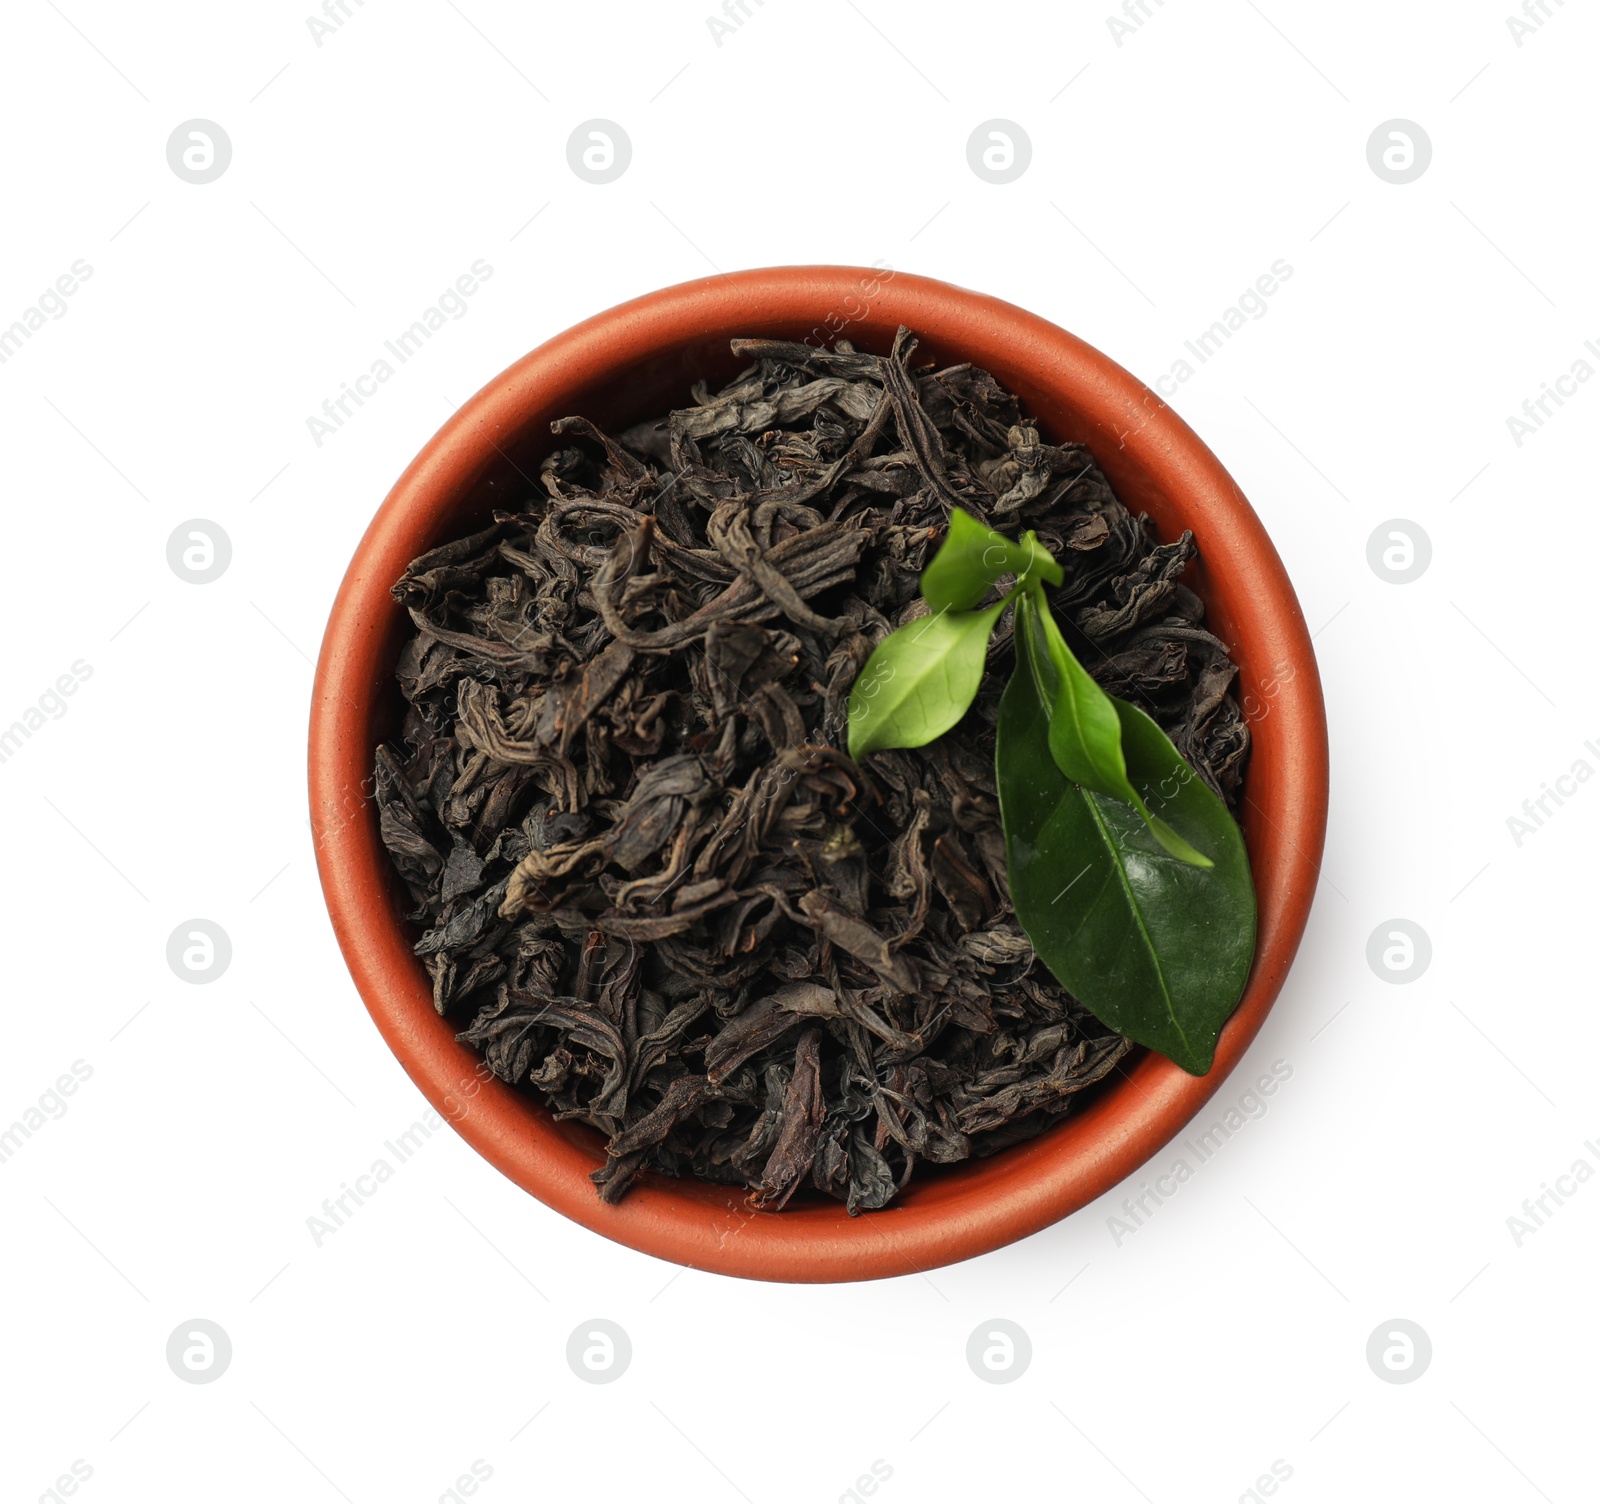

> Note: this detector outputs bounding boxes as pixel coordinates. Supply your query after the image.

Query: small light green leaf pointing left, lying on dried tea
[850,595,1011,758]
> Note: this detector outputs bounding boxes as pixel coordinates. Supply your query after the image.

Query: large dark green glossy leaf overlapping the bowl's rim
[995,634,1256,1075]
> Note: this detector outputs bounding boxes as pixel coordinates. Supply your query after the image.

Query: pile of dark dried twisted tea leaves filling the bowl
[376,330,1248,1213]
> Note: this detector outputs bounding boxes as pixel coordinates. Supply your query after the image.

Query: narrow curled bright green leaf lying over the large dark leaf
[1018,589,1211,867]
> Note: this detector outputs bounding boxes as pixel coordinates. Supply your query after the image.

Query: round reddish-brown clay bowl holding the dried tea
[310,266,1328,1282]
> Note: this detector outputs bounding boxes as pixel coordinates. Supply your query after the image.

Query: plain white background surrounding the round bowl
[0,0,1600,1504]
